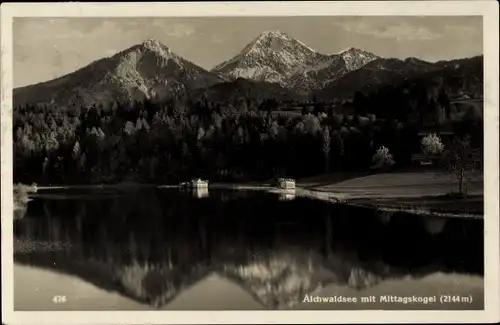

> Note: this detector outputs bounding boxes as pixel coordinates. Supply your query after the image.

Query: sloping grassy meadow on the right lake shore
[297,171,484,215]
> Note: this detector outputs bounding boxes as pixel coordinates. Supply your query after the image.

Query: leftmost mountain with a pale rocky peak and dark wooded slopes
[13,40,224,107]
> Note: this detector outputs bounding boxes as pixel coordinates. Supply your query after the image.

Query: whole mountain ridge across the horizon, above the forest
[13,35,482,106]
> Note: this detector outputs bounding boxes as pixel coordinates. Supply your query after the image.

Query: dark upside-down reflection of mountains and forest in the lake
[14,189,483,309]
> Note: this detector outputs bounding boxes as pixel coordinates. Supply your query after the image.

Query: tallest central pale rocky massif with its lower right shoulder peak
[212,31,377,92]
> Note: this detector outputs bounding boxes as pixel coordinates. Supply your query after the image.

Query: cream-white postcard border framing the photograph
[1,1,500,324]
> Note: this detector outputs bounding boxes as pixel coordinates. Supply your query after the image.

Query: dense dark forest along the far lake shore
[13,83,482,184]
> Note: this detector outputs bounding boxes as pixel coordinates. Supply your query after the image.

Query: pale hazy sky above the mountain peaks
[13,16,483,87]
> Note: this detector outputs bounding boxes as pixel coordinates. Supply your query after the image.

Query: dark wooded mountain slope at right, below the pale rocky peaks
[314,56,484,123]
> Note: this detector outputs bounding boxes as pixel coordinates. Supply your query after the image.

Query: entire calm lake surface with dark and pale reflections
[14,188,484,310]
